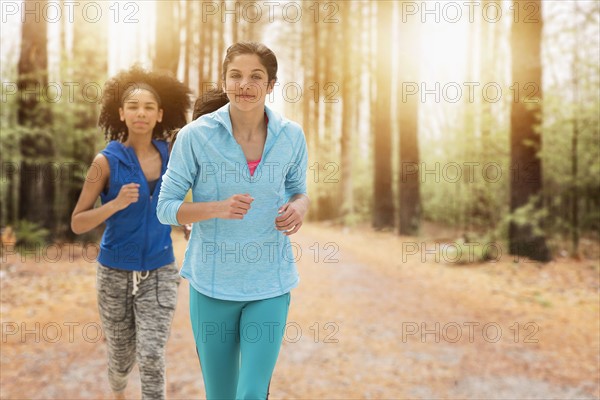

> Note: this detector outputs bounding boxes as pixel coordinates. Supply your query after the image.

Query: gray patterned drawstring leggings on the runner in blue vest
[96,263,180,400]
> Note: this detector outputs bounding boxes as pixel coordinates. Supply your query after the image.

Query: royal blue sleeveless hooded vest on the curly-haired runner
[98,140,175,271]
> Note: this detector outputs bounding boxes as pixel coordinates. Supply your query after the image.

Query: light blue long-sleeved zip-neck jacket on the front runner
[157,104,307,301]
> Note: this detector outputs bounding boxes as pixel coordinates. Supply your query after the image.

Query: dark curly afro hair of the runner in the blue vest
[98,65,191,141]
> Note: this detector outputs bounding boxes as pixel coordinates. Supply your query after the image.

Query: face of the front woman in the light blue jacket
[223,54,275,111]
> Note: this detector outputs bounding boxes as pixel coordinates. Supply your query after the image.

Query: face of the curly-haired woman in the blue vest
[119,89,163,135]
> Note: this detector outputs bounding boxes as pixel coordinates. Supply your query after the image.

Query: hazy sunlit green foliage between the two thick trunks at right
[420,101,510,238]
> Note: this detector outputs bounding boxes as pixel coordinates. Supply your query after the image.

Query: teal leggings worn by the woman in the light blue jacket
[190,286,290,400]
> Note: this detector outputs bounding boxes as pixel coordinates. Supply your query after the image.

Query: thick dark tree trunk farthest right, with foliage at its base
[509,0,550,261]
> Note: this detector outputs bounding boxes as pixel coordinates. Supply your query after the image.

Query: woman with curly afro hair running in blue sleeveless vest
[71,67,190,400]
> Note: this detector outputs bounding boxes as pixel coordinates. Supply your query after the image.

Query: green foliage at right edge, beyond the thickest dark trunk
[540,87,600,245]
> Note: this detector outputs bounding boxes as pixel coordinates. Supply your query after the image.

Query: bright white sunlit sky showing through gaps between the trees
[0,1,598,139]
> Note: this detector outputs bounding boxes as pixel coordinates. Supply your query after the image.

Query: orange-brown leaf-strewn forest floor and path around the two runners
[0,224,600,399]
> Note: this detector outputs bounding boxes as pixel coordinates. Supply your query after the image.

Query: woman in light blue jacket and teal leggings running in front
[157,43,309,400]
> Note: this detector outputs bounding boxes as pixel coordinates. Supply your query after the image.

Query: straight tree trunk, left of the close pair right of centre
[372,1,394,229]
